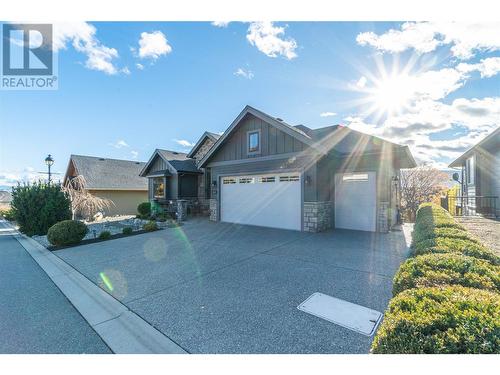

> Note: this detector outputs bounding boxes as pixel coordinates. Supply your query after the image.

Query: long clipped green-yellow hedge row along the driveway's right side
[372,204,500,353]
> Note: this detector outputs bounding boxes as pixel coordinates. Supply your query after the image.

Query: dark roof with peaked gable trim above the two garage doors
[199,105,416,168]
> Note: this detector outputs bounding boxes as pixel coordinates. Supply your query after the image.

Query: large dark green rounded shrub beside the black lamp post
[11,182,71,236]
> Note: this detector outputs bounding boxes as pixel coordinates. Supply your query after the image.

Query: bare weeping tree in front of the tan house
[62,175,115,221]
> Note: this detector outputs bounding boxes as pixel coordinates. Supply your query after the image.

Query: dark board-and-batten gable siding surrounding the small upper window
[211,115,307,162]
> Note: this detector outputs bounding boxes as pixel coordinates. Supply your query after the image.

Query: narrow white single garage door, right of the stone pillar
[335,172,377,232]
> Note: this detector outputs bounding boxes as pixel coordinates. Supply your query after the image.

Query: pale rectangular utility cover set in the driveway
[297,292,382,336]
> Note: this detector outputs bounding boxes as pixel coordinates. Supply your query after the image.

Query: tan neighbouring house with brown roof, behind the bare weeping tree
[64,155,148,215]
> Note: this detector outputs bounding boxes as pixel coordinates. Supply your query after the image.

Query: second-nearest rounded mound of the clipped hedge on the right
[392,254,500,295]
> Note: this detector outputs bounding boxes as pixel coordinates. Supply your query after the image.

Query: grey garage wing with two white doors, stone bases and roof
[197,106,416,232]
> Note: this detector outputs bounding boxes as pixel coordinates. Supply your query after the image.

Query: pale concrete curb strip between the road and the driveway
[9,224,187,354]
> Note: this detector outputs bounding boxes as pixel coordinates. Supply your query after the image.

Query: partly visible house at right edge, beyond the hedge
[450,127,500,217]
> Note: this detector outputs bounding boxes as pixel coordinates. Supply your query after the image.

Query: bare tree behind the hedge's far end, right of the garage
[401,165,449,222]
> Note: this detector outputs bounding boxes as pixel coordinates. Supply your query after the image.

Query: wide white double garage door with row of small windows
[221,173,301,230]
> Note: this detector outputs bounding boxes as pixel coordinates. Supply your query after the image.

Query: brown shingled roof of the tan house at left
[64,155,148,190]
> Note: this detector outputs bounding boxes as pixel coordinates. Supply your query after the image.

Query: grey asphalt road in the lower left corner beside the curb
[0,219,111,353]
